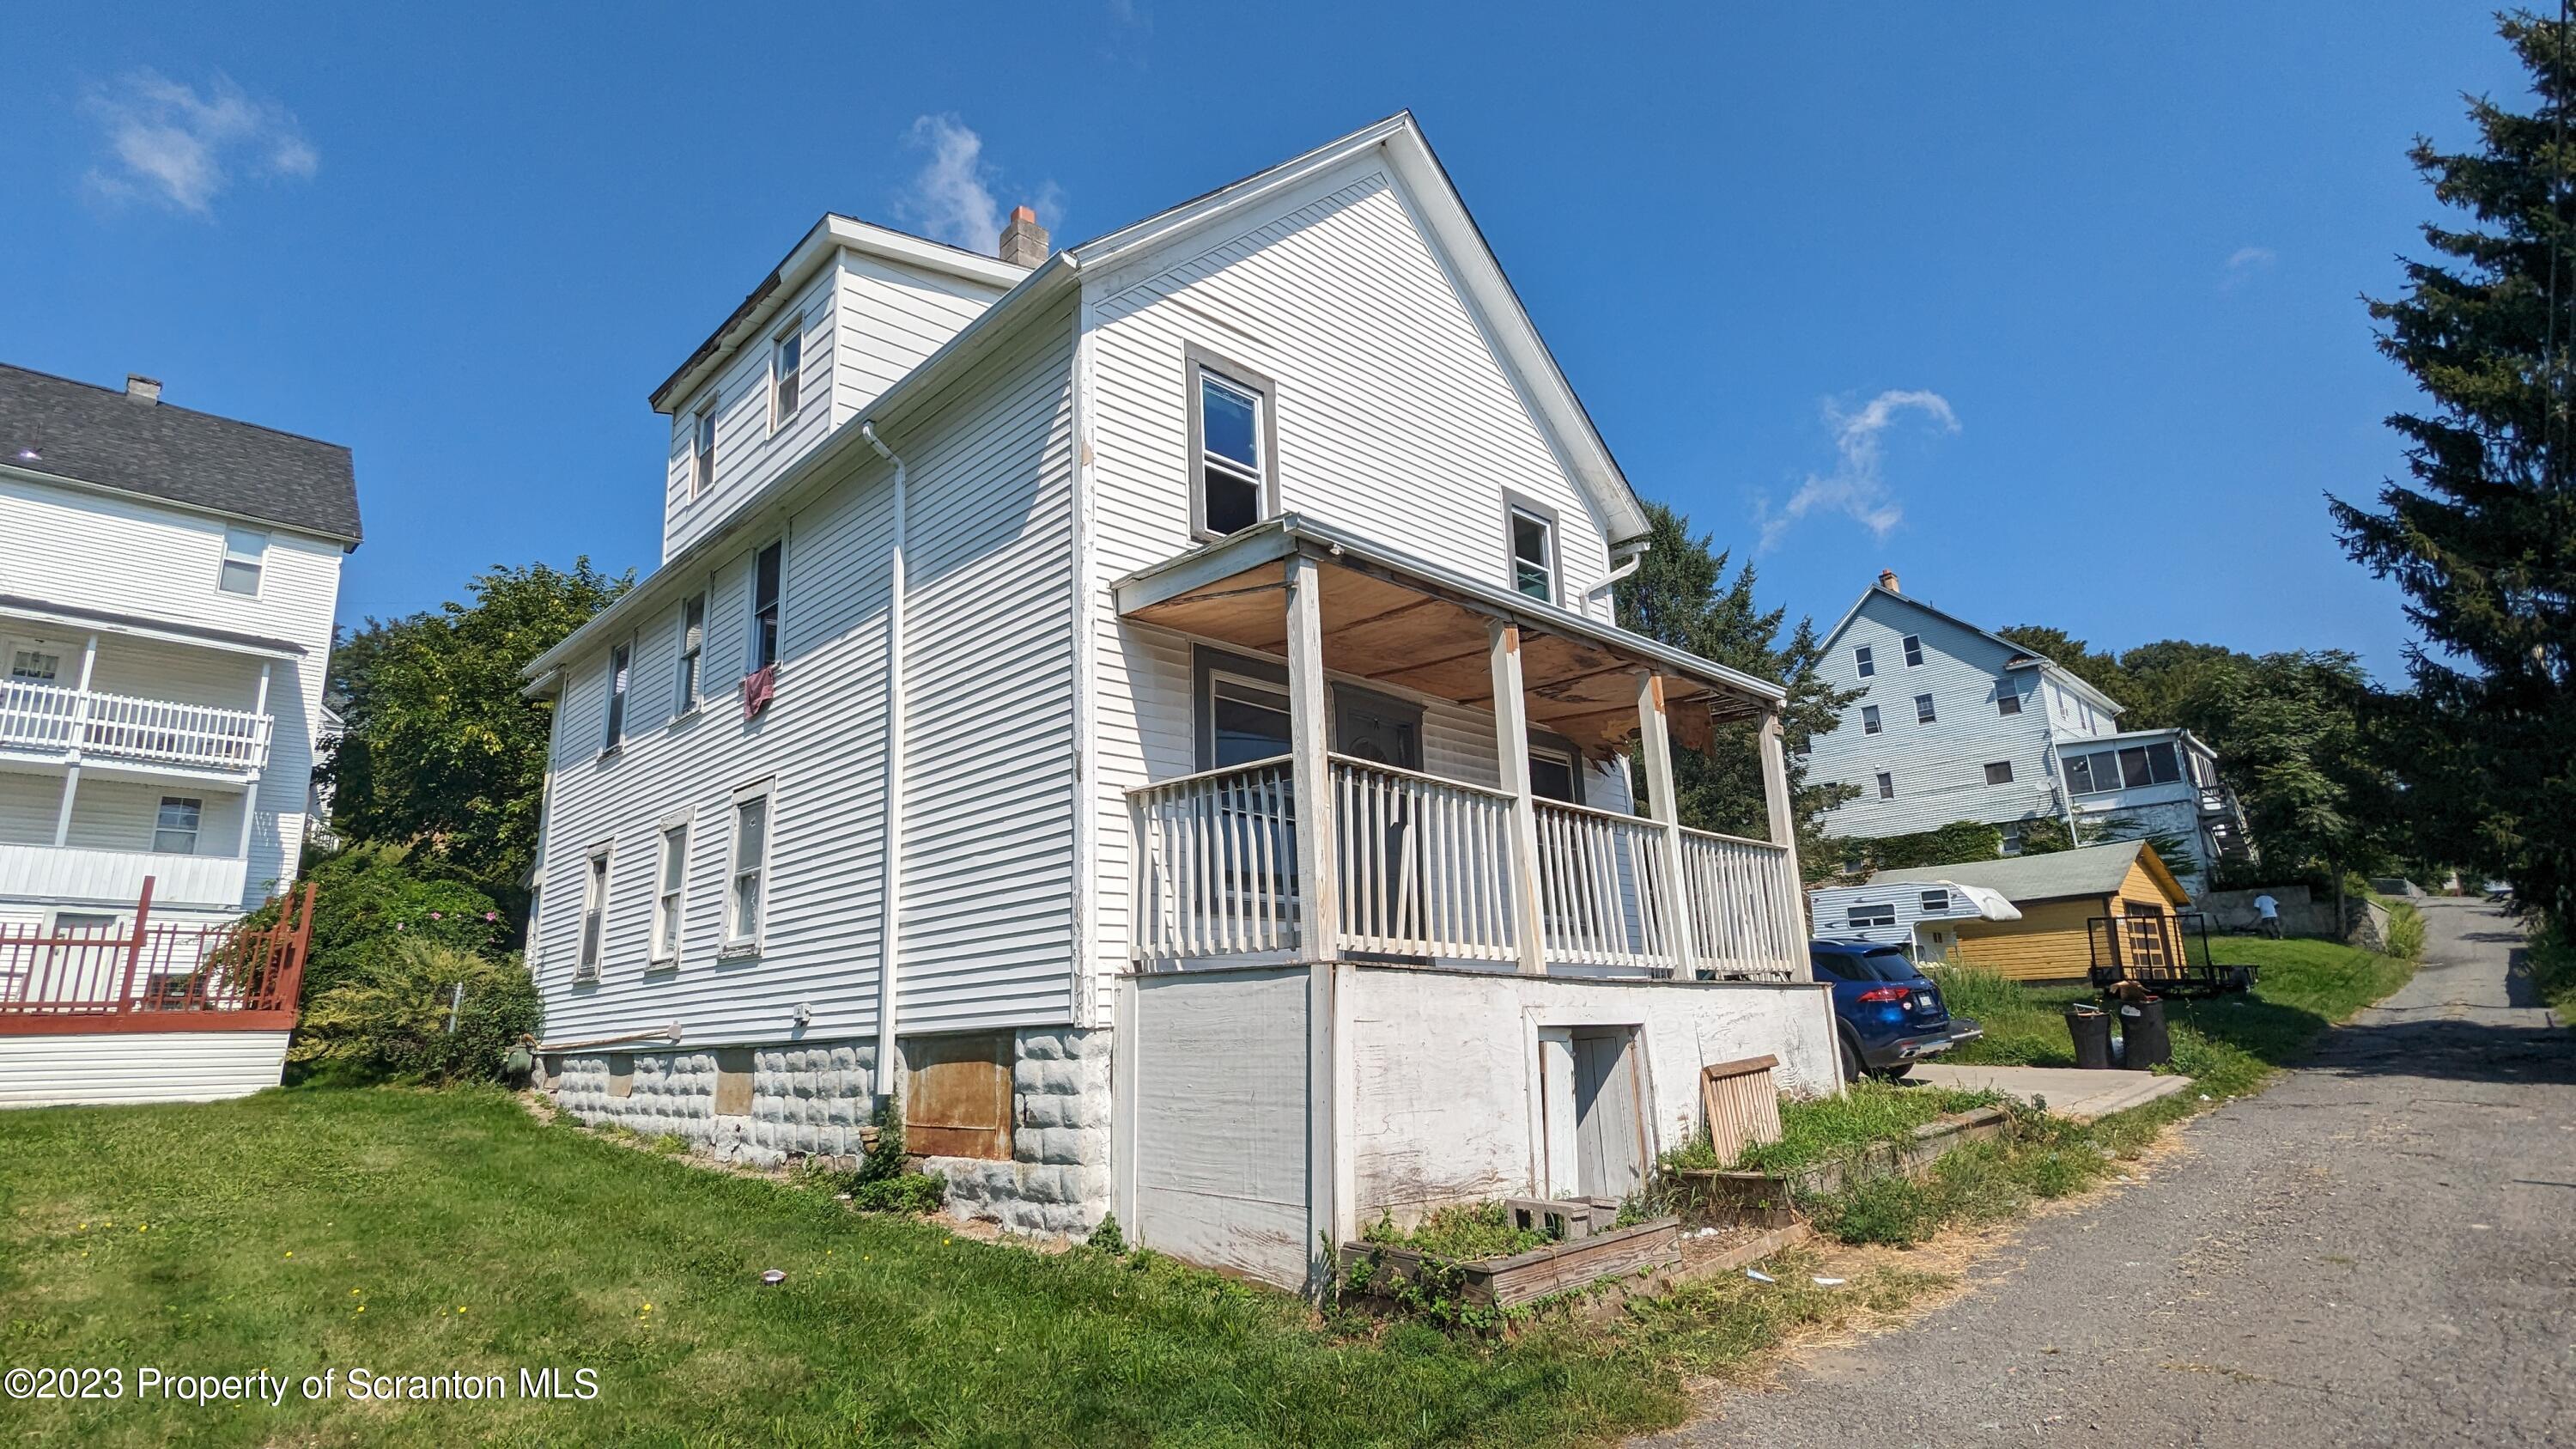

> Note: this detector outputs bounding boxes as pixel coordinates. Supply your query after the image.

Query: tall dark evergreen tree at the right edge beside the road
[2334,13,2576,921]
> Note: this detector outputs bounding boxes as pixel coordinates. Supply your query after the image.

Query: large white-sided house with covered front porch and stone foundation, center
[528,116,1837,1284]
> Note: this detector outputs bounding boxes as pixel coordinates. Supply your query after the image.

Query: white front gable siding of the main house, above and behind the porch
[1084,155,1625,1005]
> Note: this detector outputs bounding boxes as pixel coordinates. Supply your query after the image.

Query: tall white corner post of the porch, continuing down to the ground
[1288,554,1358,1278]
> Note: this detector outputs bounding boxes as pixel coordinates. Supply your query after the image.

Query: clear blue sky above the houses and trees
[0,0,2519,675]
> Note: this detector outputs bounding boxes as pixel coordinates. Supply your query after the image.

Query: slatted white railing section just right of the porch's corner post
[1332,756,1517,962]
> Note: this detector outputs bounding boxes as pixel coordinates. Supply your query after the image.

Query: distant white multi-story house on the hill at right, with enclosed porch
[1806,572,2251,895]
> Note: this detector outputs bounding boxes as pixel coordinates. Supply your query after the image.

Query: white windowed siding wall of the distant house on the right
[1806,590,2061,836]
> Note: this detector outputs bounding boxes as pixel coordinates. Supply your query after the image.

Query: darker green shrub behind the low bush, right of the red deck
[250,846,515,1008]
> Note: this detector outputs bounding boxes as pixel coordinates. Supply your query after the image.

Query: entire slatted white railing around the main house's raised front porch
[1128,756,1806,980]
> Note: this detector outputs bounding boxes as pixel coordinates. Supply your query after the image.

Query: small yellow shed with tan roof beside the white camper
[1870,841,2192,983]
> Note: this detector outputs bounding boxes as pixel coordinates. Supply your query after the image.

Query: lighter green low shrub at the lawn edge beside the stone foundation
[286,939,541,1083]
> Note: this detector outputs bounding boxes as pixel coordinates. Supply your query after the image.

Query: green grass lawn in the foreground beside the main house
[0,1088,1917,1444]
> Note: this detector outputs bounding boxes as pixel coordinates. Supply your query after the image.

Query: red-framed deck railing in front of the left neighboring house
[0,877,314,1037]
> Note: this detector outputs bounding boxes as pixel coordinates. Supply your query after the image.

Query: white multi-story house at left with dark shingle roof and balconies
[0,366,358,1106]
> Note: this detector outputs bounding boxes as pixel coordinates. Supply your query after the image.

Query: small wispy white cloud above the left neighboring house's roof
[82,70,322,216]
